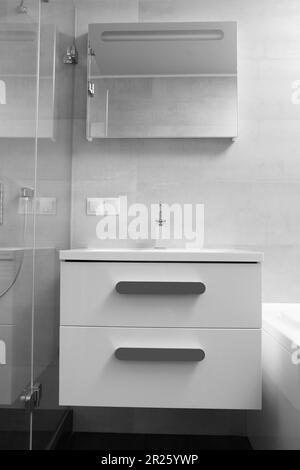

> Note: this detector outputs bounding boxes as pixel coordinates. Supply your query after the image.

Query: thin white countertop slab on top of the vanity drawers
[60,249,263,263]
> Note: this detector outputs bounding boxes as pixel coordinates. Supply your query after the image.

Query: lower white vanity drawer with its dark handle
[60,327,261,409]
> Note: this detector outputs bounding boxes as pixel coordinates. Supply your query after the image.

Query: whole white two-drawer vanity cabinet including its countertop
[60,250,262,409]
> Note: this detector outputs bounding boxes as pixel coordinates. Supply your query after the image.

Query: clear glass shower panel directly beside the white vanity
[33,0,75,449]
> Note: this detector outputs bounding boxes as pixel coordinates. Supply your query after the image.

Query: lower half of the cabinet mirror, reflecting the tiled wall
[87,75,237,140]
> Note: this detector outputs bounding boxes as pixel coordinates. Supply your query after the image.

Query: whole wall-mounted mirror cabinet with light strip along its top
[87,22,237,140]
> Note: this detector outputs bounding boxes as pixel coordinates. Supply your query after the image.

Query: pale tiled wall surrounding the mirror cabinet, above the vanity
[72,0,300,302]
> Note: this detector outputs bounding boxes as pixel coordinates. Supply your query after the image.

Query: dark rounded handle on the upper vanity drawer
[116,281,206,295]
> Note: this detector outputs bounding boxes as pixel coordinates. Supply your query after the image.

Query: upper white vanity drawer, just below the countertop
[61,262,261,328]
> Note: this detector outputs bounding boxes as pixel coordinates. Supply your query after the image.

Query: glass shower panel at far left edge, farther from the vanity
[0,0,39,449]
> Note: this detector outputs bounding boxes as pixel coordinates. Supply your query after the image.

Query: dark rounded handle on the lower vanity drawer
[115,348,205,362]
